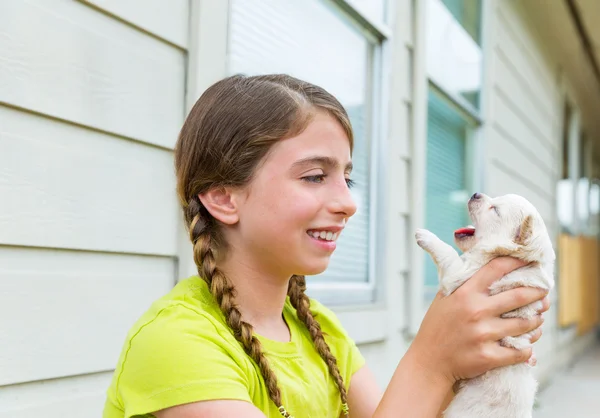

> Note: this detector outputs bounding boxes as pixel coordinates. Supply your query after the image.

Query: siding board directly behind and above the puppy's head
[487,159,556,222]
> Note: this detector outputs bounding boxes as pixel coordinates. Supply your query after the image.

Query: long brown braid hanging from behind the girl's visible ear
[186,198,293,418]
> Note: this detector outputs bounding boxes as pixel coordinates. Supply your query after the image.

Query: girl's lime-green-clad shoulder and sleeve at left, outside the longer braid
[109,279,255,416]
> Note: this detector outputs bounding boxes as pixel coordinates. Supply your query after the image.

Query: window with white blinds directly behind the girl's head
[228,0,384,304]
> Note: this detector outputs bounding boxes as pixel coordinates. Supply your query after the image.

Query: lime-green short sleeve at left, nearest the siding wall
[116,305,251,418]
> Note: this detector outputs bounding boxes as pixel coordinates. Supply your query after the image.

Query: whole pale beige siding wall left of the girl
[0,0,188,418]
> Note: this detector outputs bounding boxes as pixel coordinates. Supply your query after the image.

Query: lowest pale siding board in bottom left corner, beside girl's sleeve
[0,372,112,418]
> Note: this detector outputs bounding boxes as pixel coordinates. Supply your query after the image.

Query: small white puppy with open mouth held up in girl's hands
[415,193,555,418]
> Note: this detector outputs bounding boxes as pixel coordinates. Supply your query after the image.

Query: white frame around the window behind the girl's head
[177,0,393,314]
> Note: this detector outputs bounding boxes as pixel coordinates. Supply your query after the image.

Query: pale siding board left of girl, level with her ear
[0,106,179,255]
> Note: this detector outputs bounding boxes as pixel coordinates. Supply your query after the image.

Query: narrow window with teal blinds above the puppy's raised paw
[424,0,483,302]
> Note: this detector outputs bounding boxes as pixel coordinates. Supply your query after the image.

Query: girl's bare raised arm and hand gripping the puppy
[348,258,548,418]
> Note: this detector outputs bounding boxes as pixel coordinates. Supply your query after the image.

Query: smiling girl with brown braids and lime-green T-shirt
[104,75,548,418]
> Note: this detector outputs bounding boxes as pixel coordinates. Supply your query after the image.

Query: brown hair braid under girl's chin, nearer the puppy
[288,275,349,415]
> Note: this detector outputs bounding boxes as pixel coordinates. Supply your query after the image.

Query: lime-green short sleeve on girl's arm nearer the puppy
[310,299,365,385]
